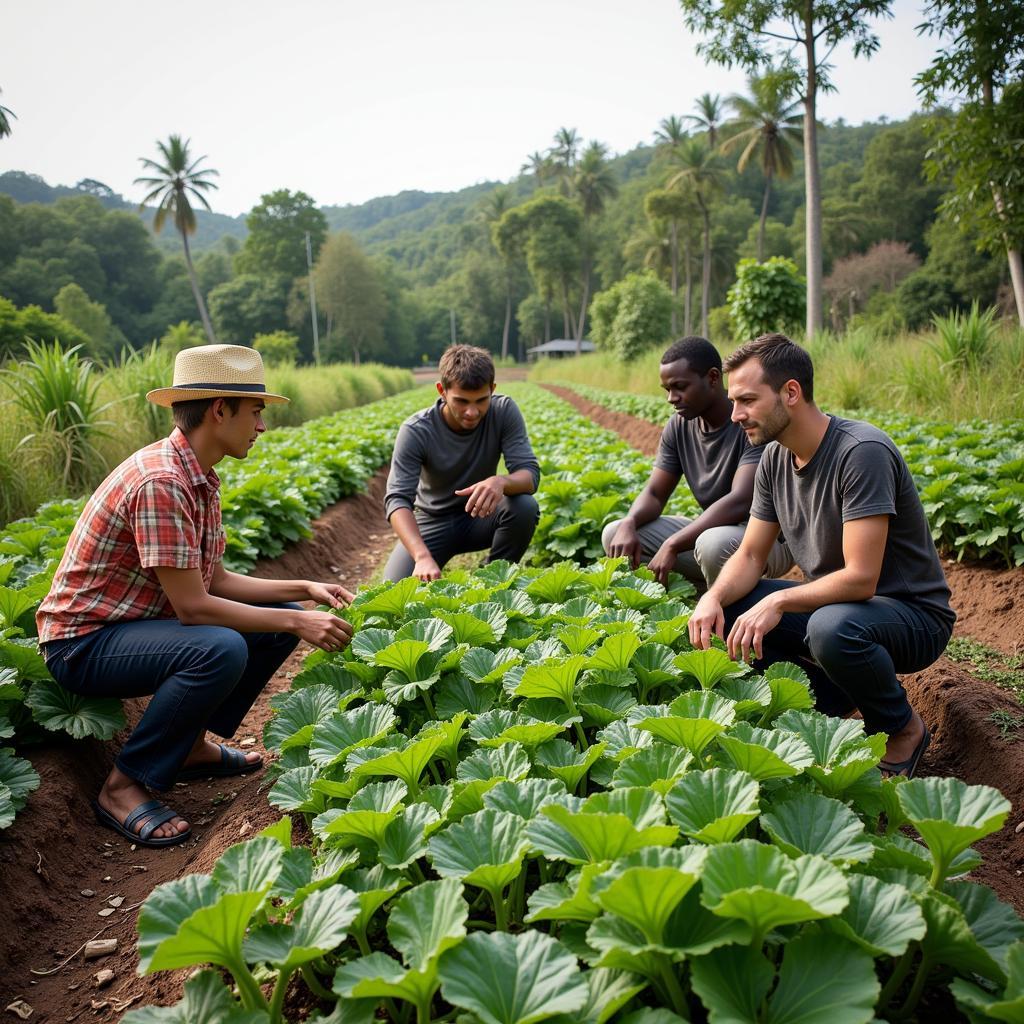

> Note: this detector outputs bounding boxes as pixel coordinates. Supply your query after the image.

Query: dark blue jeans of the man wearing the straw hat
[44,604,300,790]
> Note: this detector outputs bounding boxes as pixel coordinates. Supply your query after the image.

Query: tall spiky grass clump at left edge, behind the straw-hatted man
[0,340,114,494]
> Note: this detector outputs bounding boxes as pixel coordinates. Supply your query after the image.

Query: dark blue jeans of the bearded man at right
[725,580,952,735]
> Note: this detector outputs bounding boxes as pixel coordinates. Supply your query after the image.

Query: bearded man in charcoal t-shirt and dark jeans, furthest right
[689,334,956,776]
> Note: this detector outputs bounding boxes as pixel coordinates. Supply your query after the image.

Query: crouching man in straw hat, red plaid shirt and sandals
[36,345,352,846]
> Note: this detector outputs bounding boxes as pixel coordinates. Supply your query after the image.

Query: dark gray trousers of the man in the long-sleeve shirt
[384,495,541,583]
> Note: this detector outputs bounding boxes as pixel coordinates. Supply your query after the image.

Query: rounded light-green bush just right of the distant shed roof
[592,273,672,362]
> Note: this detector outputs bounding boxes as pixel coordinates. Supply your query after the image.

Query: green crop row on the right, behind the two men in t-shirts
[563,383,1024,567]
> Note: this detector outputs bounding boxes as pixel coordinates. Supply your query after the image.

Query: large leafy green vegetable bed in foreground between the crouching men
[125,559,1024,1024]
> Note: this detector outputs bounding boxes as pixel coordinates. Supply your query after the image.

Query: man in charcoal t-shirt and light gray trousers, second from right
[601,337,793,591]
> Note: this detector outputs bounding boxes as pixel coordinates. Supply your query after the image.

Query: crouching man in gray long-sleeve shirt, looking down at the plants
[384,345,541,582]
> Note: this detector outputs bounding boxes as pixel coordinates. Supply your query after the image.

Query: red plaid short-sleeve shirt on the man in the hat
[36,428,224,643]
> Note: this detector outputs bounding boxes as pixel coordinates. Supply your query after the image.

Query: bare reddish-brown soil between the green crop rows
[0,388,1024,1024]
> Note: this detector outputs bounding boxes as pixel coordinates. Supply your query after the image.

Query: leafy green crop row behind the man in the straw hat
[0,388,430,828]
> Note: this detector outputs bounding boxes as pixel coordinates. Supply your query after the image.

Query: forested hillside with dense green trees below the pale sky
[0,111,1006,365]
